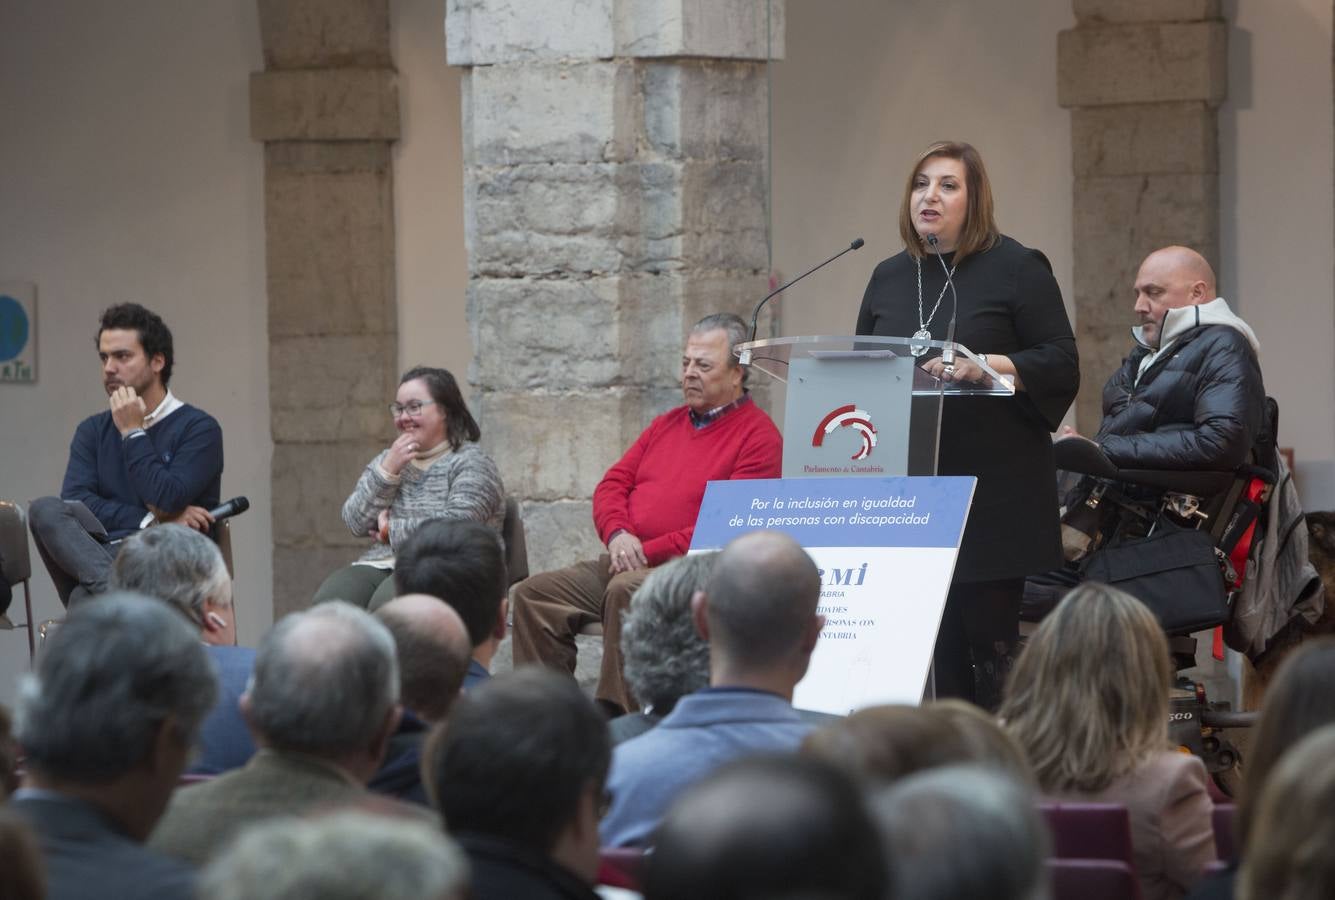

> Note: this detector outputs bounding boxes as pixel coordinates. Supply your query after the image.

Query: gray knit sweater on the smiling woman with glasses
[343,442,505,564]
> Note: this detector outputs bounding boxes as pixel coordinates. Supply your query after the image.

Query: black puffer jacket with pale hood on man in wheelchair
[1095,298,1266,471]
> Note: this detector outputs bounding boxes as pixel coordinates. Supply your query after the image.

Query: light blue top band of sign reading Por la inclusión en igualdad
[690,475,977,550]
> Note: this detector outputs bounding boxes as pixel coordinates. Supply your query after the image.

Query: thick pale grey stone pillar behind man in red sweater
[446,0,782,572]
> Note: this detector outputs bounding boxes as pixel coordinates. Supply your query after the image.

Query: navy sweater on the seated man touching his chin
[60,403,223,539]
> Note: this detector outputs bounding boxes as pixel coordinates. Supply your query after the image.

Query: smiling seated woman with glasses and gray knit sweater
[315,366,505,610]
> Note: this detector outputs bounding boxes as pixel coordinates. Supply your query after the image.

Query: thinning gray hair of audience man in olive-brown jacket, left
[247,601,399,758]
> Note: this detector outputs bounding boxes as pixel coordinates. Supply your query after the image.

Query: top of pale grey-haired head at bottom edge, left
[199,806,469,900]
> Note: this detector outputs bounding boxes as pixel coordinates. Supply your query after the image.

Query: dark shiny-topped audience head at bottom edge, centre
[645,756,886,900]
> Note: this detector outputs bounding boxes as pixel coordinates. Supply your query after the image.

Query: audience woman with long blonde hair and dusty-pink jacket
[1001,582,1215,900]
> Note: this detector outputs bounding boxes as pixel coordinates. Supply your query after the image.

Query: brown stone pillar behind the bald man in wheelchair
[1057,0,1227,433]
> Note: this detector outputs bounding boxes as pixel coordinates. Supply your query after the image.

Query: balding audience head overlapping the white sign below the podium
[692,531,825,697]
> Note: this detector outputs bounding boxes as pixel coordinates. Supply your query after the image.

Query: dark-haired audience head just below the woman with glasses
[394,518,509,648]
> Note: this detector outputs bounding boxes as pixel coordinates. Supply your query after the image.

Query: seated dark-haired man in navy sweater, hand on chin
[28,303,223,606]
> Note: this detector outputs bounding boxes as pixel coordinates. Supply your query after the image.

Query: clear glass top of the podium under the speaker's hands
[736,335,1015,397]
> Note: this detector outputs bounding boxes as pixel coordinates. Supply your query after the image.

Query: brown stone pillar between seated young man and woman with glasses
[251,0,399,618]
